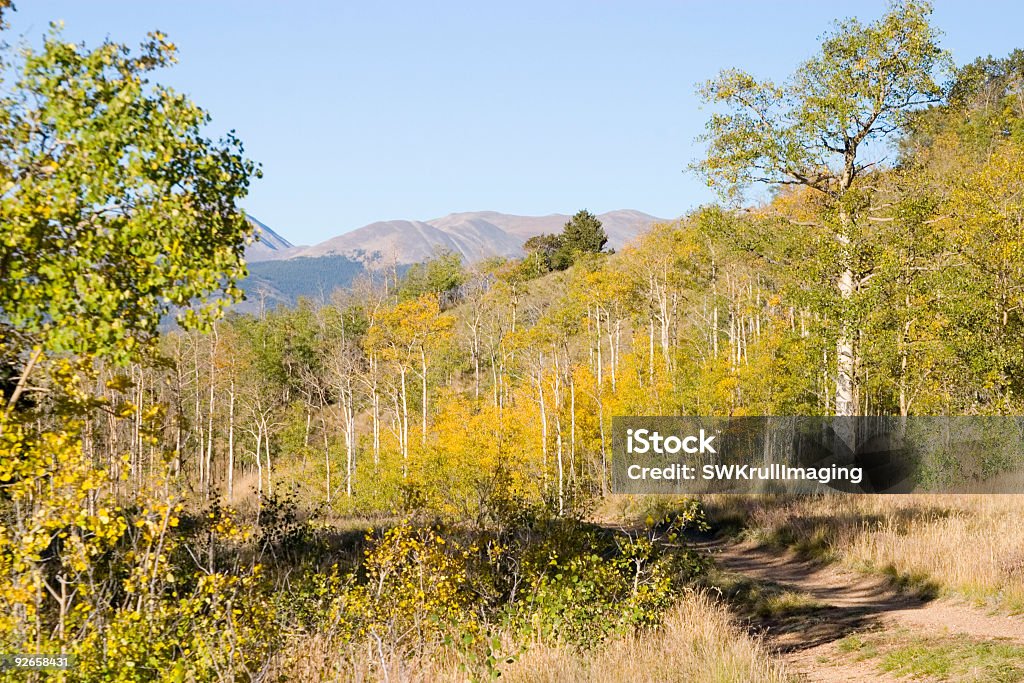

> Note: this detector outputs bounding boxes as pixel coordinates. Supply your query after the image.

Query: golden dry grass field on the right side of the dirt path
[708,495,1024,612]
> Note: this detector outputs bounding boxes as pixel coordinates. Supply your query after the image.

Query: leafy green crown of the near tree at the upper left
[0,30,257,362]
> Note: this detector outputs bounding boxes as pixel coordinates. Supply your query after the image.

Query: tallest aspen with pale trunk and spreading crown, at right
[697,0,948,416]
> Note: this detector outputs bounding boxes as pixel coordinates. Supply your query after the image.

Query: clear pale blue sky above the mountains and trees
[7,0,1024,244]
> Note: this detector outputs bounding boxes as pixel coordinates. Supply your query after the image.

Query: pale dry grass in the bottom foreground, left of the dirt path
[272,592,787,683]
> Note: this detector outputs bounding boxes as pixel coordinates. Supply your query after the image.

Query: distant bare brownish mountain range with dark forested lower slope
[238,209,663,312]
